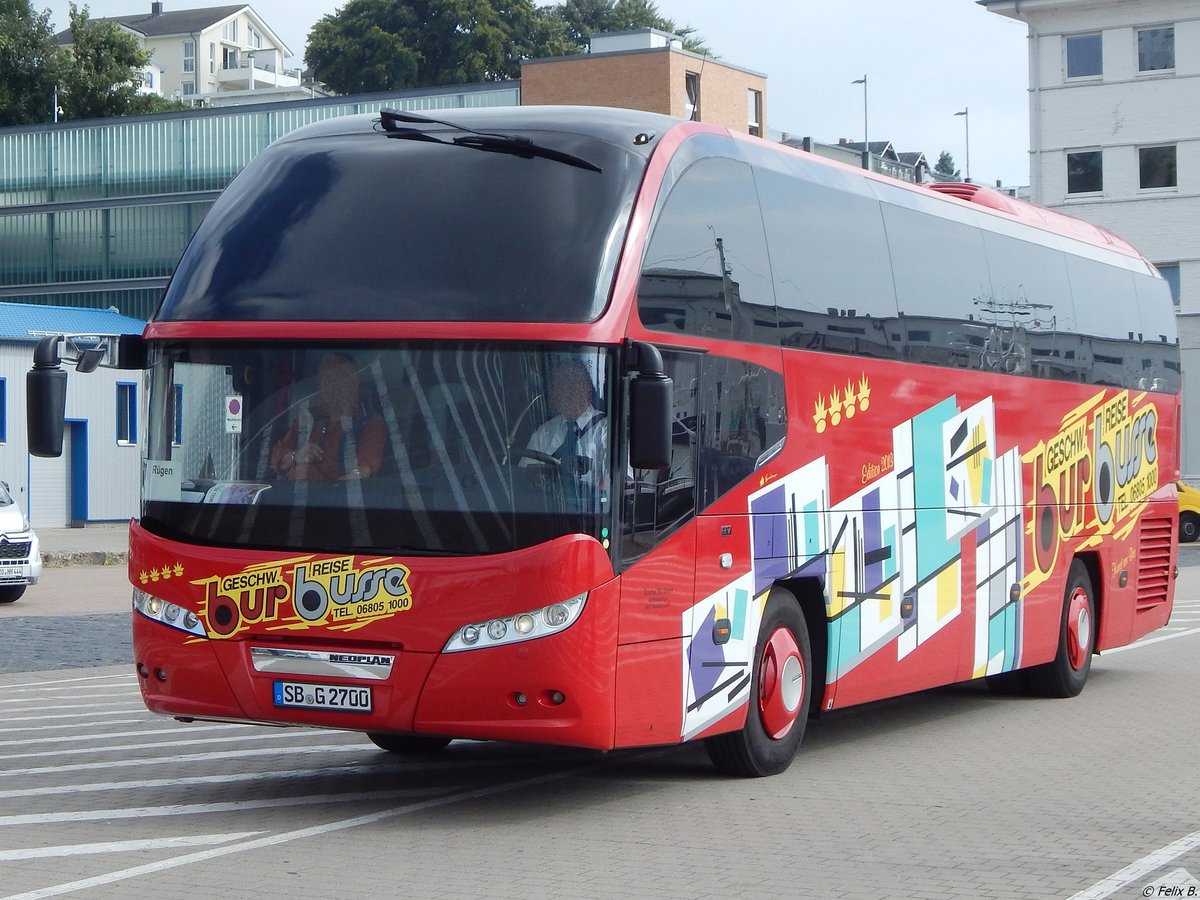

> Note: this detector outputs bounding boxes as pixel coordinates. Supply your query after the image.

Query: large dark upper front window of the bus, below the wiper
[156,132,644,322]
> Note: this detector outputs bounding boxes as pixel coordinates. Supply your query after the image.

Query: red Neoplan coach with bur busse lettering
[30,107,1180,775]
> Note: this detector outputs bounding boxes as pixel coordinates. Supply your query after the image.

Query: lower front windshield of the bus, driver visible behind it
[142,341,613,554]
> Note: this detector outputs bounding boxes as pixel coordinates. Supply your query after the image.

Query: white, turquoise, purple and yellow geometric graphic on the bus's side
[683,396,1024,738]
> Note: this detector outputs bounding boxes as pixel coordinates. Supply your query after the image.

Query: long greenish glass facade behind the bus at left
[0,82,521,319]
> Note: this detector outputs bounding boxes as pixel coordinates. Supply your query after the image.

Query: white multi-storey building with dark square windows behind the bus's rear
[978,0,1200,482]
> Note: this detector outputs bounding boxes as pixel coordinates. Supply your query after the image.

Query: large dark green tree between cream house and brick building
[305,0,540,94]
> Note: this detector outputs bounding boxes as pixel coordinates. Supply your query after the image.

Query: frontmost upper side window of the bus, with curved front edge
[637,157,778,343]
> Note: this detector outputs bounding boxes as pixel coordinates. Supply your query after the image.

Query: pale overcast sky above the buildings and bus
[44,0,1030,185]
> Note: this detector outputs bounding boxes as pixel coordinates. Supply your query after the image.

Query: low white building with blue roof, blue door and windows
[0,302,145,528]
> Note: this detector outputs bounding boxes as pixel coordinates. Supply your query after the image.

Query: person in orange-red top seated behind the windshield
[271,353,384,481]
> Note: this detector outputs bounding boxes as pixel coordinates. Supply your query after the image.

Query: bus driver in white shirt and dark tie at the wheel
[520,360,608,509]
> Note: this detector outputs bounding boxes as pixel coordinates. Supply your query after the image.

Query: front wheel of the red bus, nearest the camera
[704,592,812,778]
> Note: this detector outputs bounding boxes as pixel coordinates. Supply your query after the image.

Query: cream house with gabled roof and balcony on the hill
[58,0,312,106]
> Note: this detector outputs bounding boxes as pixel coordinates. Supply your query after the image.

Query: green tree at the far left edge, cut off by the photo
[0,0,66,126]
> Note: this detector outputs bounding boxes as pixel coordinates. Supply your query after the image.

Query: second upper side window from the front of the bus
[755,163,900,356]
